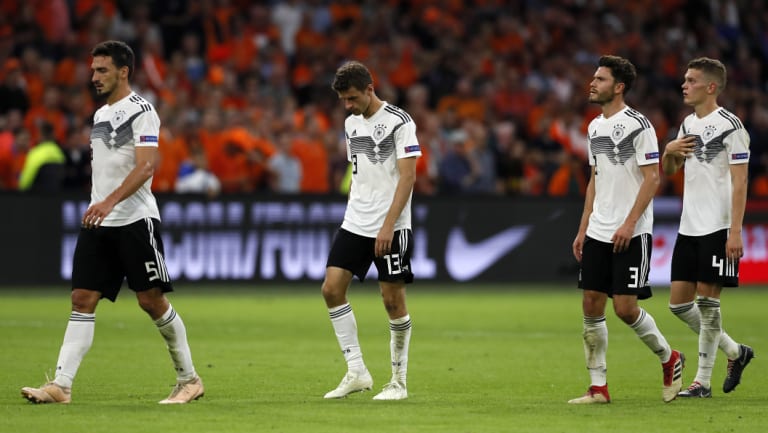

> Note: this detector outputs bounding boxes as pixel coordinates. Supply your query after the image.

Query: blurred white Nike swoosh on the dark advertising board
[445,225,531,281]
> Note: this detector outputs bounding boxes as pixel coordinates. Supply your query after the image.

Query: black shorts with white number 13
[326,229,413,283]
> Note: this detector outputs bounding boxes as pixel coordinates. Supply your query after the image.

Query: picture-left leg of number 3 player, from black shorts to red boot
[568,238,612,404]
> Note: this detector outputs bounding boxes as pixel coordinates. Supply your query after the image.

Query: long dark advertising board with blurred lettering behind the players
[0,194,768,287]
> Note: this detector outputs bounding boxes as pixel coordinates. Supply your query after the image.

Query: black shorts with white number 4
[671,229,739,287]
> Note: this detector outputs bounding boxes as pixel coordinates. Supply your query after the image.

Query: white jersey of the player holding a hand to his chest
[677,108,749,236]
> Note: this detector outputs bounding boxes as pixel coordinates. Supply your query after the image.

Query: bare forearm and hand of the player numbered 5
[83,146,158,228]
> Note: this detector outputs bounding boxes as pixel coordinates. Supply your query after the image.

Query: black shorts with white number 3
[579,233,653,299]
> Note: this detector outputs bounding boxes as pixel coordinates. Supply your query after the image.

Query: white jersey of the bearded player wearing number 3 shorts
[587,107,659,242]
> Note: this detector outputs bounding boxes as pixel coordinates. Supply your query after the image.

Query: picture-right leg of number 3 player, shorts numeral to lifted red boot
[612,233,685,402]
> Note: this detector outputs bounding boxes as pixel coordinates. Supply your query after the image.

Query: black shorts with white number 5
[72,218,173,302]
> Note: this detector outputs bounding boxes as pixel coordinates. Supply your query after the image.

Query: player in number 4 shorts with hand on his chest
[662,57,755,398]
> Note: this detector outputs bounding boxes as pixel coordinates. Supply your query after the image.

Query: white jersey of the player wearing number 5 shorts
[91,92,160,227]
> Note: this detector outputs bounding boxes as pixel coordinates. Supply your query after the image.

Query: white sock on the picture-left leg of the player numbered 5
[53,311,96,388]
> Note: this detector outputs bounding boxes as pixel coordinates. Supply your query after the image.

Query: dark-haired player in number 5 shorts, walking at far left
[21,41,203,404]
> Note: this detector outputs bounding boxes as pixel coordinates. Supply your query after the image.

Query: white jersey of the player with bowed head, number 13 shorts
[341,102,421,238]
